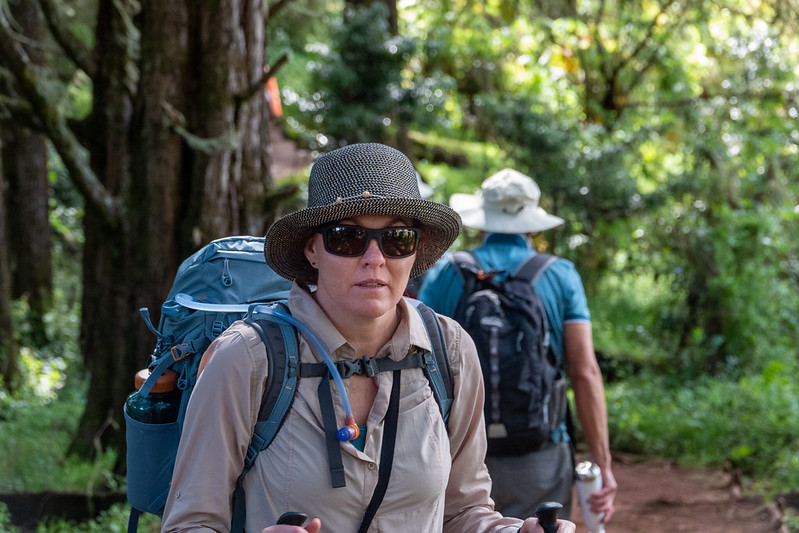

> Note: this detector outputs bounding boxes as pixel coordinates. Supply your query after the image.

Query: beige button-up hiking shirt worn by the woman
[163,284,521,533]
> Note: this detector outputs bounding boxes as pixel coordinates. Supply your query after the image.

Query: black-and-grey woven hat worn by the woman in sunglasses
[264,143,462,284]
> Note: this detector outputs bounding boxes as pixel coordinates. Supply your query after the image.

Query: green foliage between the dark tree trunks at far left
[0,165,101,493]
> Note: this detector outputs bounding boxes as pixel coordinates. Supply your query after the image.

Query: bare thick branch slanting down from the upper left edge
[0,10,122,228]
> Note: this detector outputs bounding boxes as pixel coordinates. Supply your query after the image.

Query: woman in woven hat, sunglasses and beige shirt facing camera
[163,144,575,533]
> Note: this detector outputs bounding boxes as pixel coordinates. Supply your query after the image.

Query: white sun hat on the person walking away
[449,168,563,233]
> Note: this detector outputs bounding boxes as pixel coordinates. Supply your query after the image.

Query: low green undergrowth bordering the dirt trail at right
[607,362,799,491]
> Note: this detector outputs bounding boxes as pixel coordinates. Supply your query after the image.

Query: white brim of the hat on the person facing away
[449,193,564,233]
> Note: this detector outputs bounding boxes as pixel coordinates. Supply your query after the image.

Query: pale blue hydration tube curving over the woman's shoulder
[175,292,359,442]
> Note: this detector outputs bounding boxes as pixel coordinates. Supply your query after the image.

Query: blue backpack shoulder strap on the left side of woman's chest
[230,303,300,533]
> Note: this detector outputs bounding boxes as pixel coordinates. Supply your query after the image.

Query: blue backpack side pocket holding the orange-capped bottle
[125,408,180,516]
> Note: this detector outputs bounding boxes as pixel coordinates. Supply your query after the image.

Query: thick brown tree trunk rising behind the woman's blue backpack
[66,0,271,455]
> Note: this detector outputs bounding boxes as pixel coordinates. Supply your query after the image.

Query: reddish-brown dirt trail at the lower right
[572,455,779,533]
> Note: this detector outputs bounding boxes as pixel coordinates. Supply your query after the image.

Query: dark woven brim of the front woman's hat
[264,198,462,284]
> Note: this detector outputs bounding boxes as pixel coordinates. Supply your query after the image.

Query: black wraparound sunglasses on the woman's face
[314,224,422,258]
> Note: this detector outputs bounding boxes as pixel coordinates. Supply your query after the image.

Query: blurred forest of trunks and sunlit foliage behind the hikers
[0,0,799,531]
